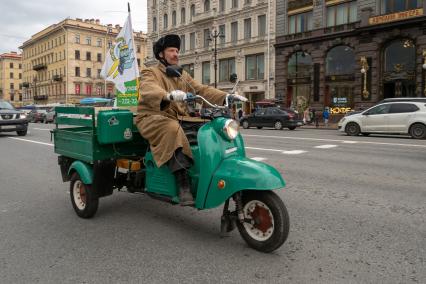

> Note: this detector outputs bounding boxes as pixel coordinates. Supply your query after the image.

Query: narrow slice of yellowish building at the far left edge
[0,52,22,106]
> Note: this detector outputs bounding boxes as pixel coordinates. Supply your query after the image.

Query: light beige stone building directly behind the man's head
[146,0,275,112]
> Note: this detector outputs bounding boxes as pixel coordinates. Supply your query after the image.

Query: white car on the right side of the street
[338,98,426,139]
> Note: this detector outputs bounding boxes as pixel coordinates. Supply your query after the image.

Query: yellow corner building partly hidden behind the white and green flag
[21,19,146,104]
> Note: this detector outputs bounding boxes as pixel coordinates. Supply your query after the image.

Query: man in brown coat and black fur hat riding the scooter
[136,34,246,206]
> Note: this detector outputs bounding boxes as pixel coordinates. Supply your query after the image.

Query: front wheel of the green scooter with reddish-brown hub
[237,191,290,252]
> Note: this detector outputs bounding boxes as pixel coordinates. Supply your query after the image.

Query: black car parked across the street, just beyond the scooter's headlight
[240,107,303,130]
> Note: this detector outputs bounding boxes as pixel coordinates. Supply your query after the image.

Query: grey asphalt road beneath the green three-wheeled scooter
[0,124,426,283]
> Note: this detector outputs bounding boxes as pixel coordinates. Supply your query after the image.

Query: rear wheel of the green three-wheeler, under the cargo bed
[70,172,99,219]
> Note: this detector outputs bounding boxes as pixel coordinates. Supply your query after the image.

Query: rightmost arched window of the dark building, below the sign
[384,39,416,73]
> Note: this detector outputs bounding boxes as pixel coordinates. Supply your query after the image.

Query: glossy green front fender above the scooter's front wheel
[204,156,285,209]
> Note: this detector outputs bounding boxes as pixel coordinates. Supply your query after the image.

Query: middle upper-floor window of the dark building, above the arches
[327,1,357,27]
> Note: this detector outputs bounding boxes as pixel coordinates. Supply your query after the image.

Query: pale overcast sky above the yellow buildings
[0,0,147,54]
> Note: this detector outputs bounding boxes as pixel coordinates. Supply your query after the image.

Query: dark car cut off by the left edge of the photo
[0,100,28,136]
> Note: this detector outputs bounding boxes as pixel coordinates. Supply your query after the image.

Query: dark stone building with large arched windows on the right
[275,0,426,118]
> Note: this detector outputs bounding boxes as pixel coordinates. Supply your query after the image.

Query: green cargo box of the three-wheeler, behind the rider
[52,107,148,163]
